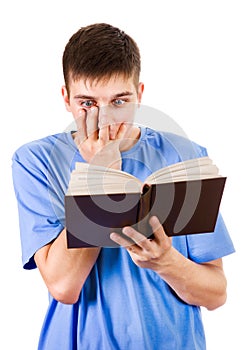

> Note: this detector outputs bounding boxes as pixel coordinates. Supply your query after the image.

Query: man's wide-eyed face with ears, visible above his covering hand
[62,76,143,128]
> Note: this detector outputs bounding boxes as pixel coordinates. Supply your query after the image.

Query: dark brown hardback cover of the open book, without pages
[65,177,226,248]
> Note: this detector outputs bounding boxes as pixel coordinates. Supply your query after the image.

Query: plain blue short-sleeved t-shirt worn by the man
[13,127,234,350]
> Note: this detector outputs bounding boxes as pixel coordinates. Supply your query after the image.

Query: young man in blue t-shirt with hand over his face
[13,23,234,350]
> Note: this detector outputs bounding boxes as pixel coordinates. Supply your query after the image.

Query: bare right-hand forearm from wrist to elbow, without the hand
[156,247,227,310]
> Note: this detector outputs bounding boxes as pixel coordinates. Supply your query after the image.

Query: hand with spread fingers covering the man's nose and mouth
[74,107,127,169]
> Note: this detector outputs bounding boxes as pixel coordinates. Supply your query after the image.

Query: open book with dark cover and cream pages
[65,157,226,248]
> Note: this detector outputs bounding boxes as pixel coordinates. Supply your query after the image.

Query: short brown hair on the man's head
[63,23,141,93]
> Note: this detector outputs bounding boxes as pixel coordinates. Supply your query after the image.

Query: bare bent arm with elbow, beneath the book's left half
[35,229,100,304]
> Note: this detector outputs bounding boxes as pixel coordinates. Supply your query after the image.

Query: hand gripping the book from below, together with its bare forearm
[110,217,226,310]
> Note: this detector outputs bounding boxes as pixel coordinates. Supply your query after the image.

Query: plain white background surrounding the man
[0,0,250,350]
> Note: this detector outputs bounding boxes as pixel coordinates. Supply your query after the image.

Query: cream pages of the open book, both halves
[67,157,220,195]
